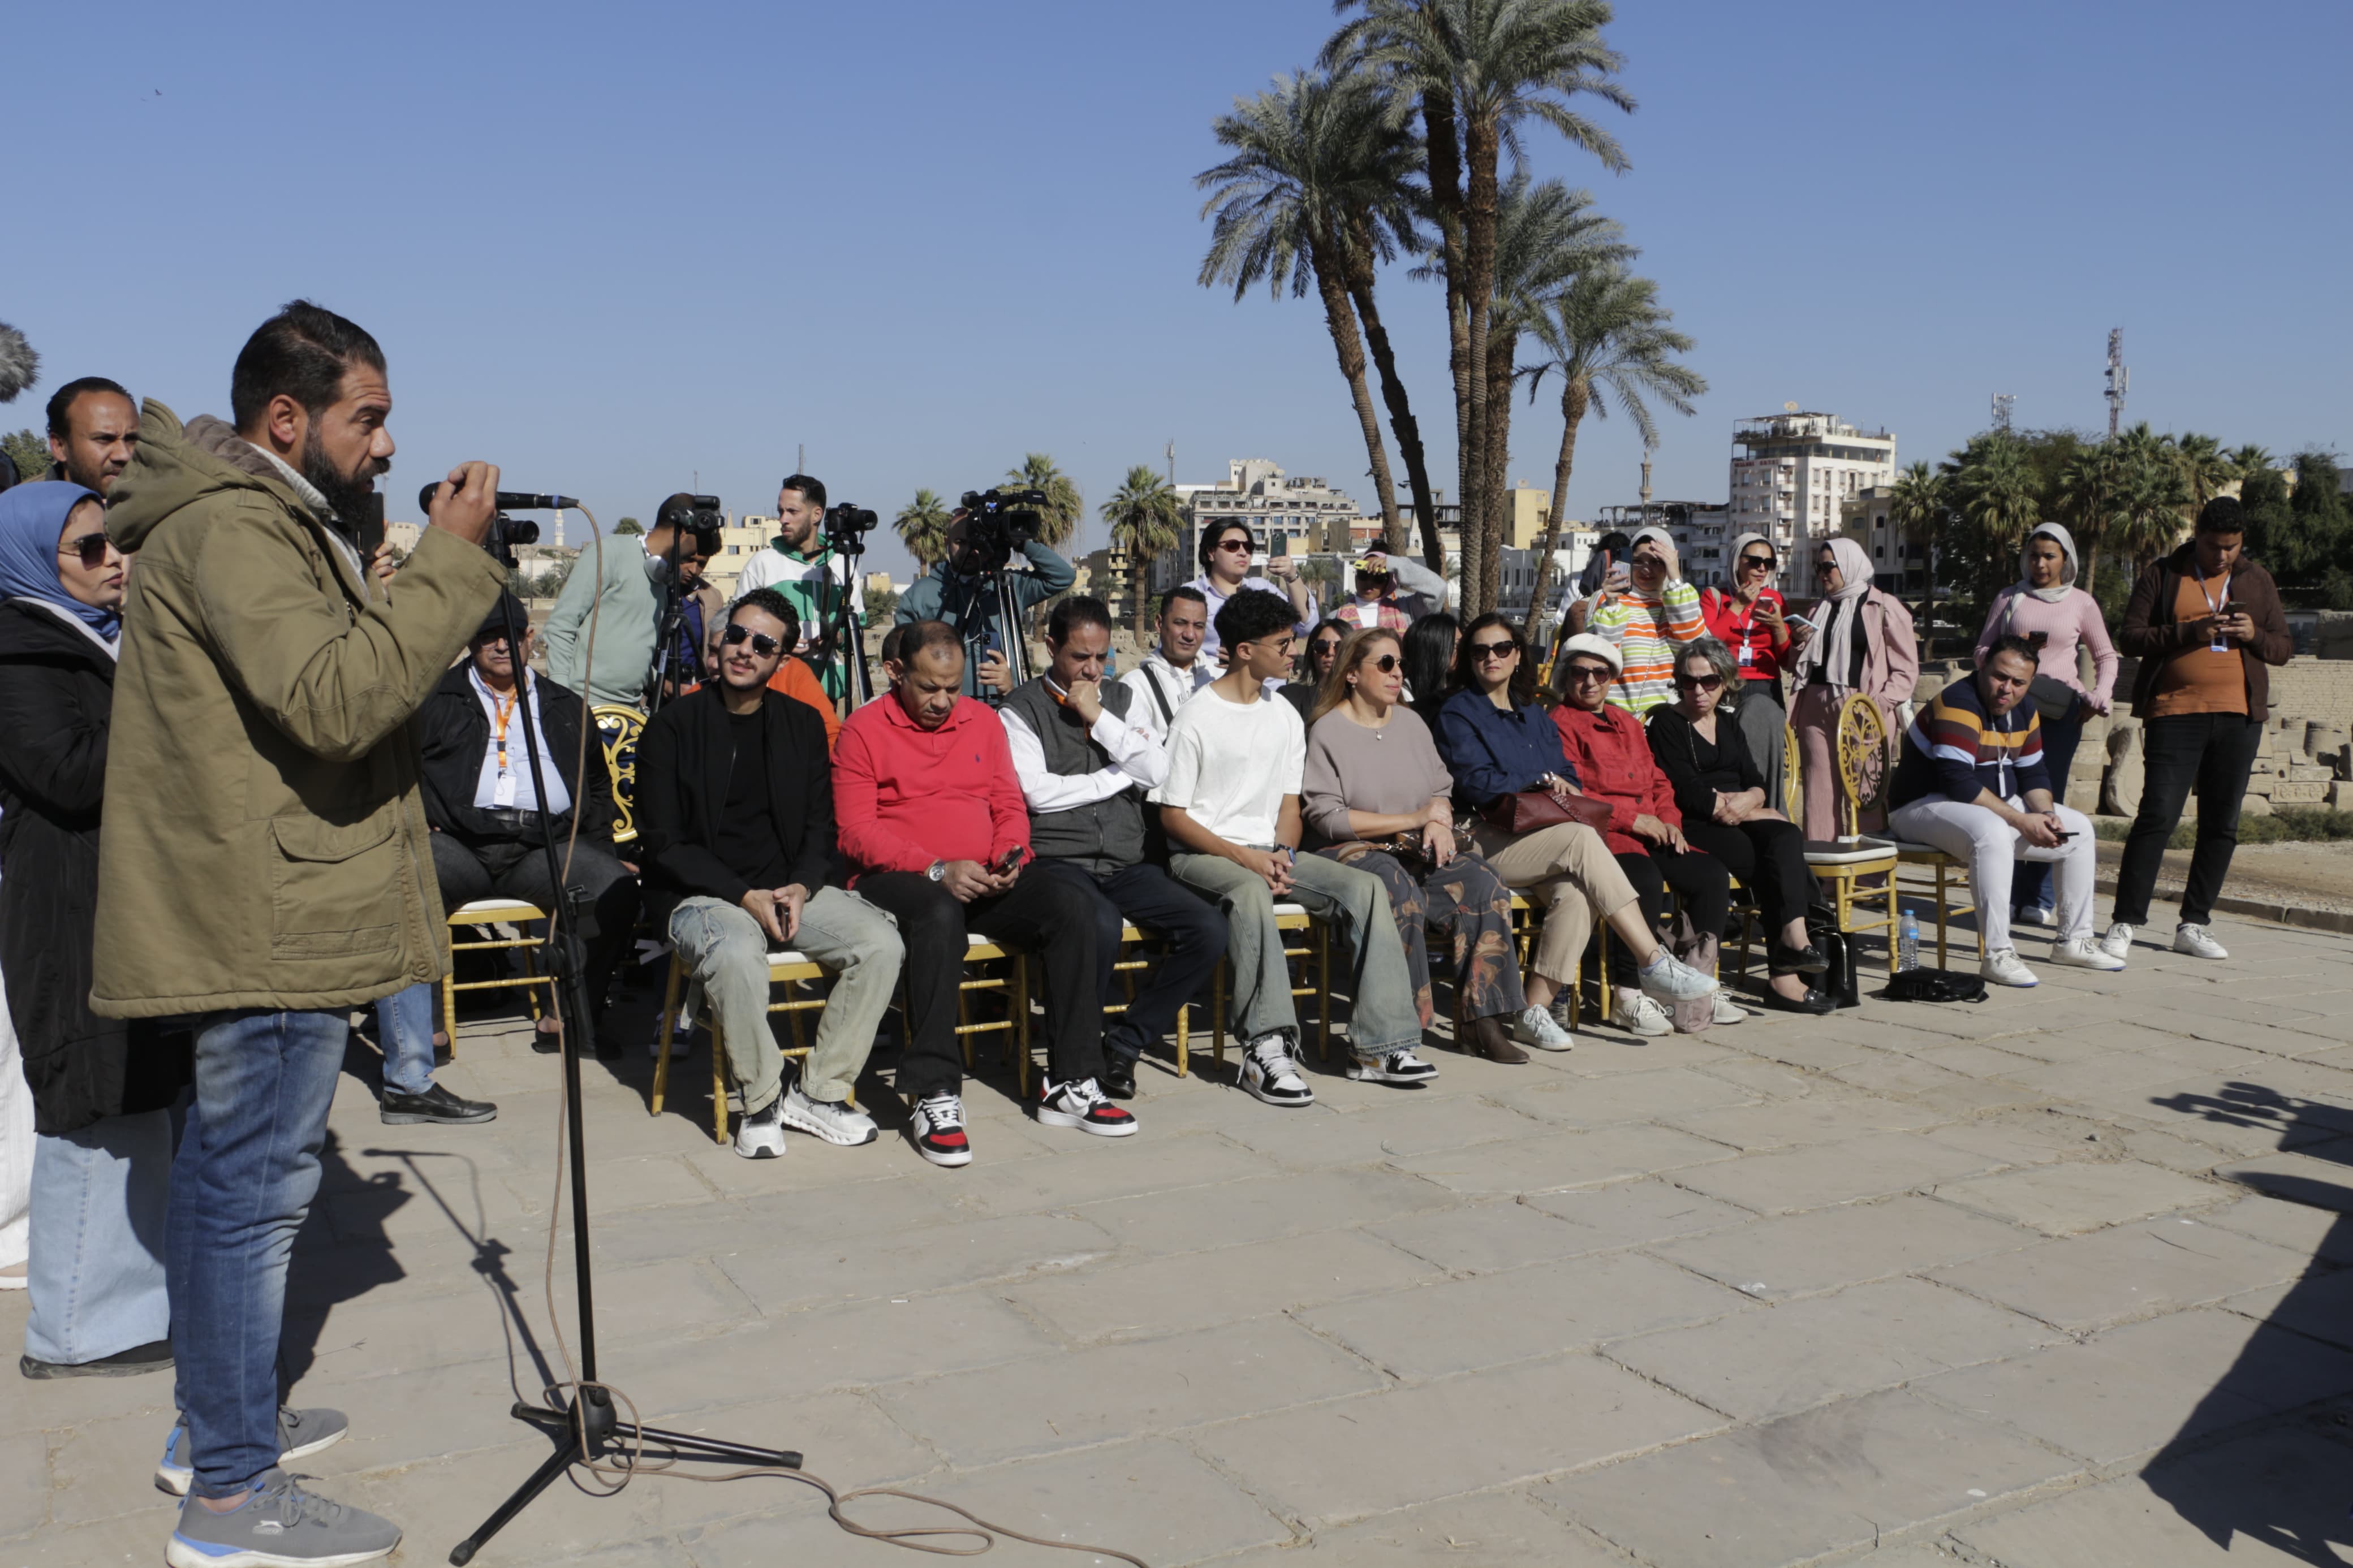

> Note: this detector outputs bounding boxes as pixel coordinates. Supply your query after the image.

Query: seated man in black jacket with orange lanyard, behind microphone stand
[416,595,637,1051]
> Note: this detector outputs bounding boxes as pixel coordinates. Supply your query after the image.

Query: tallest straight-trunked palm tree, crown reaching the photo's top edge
[1325,0,1633,611]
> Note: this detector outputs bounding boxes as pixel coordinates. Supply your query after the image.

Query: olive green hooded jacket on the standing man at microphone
[89,400,506,1018]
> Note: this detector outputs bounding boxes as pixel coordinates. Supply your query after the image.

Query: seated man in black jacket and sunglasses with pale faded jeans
[635,588,906,1159]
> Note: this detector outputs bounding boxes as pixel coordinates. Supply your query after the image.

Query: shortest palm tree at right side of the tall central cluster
[1515,261,1708,628]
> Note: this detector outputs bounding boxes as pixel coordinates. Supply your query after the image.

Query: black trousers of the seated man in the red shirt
[859,861,1104,1098]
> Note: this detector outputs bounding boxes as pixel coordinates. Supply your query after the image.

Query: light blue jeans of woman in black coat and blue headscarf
[24,1109,172,1366]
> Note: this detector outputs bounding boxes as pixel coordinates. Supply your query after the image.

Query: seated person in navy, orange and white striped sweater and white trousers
[1889,632,2124,985]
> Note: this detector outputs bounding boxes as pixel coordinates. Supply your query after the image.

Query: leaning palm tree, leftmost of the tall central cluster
[1193,73,1407,552]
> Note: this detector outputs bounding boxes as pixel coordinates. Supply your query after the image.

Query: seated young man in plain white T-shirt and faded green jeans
[1150,593,1438,1105]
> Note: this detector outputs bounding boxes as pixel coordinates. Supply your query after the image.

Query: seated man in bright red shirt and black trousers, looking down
[833,621,1136,1166]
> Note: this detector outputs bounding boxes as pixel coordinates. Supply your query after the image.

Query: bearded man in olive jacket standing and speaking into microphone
[89,301,506,1563]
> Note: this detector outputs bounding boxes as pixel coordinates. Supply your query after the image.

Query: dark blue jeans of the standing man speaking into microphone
[165,1009,351,1497]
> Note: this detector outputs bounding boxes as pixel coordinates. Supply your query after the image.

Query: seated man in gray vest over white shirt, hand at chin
[998,595,1226,1100]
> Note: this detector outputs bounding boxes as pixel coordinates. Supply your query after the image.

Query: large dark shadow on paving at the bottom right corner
[2141,1084,2353,1568]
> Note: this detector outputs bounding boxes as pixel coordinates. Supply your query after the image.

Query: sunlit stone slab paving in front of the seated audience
[0,922,2353,1568]
